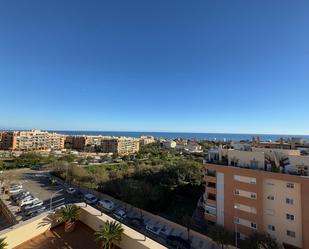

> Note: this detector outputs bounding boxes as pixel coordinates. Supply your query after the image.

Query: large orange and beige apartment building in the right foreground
[203,147,309,249]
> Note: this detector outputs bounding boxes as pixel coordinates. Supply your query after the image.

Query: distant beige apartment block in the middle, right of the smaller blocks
[101,137,139,155]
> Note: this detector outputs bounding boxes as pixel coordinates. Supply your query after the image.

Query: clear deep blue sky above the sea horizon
[0,0,309,134]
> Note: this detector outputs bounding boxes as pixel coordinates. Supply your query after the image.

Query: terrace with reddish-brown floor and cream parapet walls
[0,203,166,249]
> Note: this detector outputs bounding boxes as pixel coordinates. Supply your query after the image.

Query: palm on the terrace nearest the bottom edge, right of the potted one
[94,221,123,249]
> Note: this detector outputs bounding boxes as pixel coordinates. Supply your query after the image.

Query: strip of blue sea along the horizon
[50,130,309,141]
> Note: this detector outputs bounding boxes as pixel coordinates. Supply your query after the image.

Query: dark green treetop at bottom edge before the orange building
[244,233,282,249]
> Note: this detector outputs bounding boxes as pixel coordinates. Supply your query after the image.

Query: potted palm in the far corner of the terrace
[54,204,80,232]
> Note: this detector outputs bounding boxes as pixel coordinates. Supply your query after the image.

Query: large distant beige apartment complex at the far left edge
[0,130,65,151]
